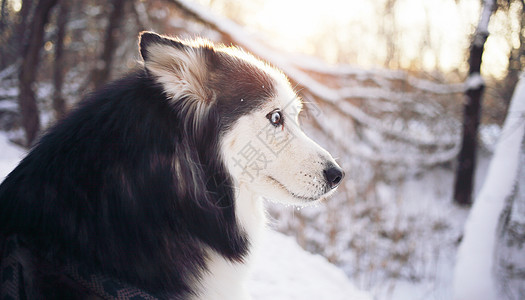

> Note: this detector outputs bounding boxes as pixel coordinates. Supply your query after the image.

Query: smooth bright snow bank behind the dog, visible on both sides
[0,134,372,300]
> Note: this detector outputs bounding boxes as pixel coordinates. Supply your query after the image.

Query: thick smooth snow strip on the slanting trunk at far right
[454,74,525,300]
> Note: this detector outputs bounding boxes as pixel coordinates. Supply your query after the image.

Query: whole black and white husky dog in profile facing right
[0,32,344,300]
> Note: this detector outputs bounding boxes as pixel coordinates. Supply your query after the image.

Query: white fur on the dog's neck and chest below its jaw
[195,183,266,300]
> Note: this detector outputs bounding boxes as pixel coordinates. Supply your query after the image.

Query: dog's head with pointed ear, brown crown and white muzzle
[140,32,344,205]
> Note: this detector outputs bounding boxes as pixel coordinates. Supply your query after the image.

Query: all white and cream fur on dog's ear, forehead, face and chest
[145,35,337,300]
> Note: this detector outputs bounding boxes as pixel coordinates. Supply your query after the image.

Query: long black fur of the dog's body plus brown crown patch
[0,36,273,299]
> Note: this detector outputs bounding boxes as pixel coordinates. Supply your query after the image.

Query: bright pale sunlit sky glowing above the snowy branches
[196,0,509,78]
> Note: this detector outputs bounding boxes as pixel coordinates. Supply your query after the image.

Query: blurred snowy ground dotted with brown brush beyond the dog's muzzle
[274,152,490,300]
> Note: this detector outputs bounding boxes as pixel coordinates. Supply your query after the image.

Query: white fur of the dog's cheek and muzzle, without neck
[223,80,337,205]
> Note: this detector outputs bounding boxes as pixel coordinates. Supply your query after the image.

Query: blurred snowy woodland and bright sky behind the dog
[0,0,525,299]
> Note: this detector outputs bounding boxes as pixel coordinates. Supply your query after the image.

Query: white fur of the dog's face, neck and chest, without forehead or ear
[195,81,337,300]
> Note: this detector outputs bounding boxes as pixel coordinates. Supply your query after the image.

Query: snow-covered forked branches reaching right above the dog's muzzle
[165,0,465,165]
